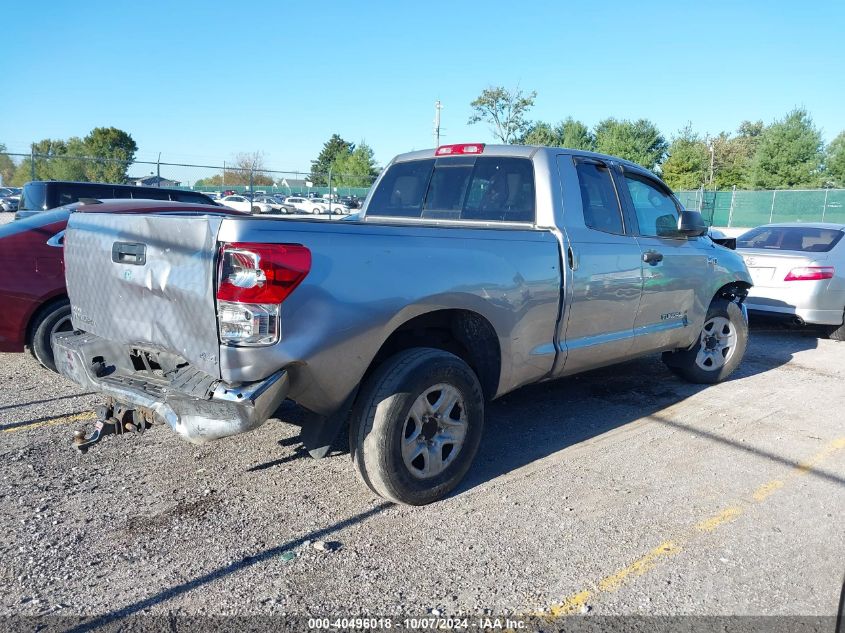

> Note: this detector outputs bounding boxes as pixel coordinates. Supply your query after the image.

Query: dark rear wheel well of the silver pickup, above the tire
[364,310,502,399]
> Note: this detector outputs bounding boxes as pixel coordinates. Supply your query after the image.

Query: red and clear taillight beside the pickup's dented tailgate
[217,242,311,345]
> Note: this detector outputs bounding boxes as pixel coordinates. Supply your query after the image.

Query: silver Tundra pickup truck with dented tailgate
[54,144,751,504]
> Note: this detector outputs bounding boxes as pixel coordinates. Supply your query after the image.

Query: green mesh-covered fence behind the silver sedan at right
[675,189,845,228]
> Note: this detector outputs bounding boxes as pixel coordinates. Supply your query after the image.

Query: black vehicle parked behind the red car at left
[15,180,215,220]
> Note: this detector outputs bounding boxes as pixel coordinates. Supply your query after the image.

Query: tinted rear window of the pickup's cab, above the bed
[367,156,535,222]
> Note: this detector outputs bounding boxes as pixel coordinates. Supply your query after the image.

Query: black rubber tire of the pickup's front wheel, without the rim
[663,298,748,385]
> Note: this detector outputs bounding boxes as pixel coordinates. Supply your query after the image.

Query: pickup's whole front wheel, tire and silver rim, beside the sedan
[663,299,748,384]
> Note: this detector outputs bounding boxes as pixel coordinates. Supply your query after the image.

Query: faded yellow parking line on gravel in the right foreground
[535,437,845,617]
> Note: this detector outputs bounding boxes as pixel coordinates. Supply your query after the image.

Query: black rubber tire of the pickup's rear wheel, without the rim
[349,347,484,505]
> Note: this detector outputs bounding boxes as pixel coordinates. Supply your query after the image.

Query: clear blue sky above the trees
[0,0,845,179]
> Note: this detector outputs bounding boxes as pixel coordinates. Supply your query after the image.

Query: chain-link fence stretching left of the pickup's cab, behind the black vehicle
[0,152,375,198]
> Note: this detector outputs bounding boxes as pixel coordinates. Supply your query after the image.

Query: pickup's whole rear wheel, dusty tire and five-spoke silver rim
[349,347,484,505]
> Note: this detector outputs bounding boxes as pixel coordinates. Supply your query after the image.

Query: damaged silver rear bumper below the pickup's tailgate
[53,332,289,443]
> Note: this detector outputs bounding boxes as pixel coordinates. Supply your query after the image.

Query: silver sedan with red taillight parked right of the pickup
[736,222,845,341]
